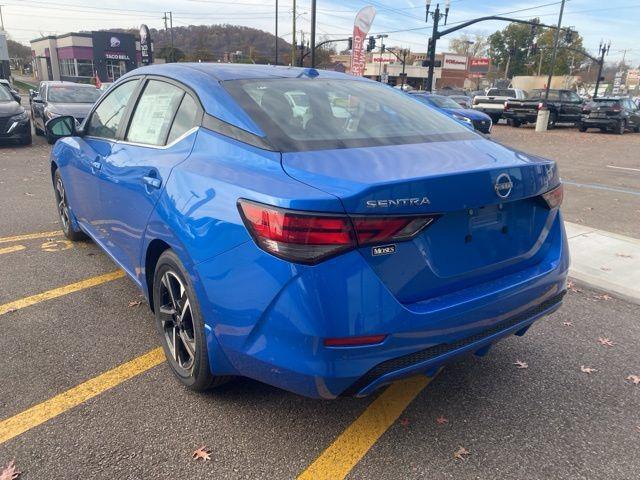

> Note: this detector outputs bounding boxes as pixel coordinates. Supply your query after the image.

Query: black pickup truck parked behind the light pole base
[502,89,584,128]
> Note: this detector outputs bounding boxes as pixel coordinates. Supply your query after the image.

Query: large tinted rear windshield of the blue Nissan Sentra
[223,78,478,151]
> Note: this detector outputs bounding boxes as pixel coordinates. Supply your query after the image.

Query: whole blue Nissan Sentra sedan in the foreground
[47,63,569,398]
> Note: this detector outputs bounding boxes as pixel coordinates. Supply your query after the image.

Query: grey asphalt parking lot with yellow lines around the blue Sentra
[0,117,640,479]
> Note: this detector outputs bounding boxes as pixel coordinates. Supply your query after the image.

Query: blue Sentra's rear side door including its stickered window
[94,78,202,272]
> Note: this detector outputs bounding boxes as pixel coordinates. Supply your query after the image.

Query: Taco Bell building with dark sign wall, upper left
[31,31,153,83]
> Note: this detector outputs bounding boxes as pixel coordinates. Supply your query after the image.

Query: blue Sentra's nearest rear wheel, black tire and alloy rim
[153,250,230,392]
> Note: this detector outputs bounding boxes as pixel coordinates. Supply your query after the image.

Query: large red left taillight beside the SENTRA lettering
[238,200,438,264]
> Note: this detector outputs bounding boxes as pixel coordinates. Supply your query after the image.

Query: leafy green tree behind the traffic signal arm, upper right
[489,19,584,77]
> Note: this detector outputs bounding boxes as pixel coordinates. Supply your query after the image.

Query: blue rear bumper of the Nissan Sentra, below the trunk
[196,215,569,398]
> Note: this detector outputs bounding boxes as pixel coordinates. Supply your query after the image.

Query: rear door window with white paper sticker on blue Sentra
[126,80,185,145]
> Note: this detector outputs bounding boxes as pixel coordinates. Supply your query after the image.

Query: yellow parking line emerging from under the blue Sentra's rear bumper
[298,376,431,480]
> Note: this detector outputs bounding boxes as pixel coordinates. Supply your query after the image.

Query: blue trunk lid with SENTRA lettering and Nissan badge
[282,140,558,303]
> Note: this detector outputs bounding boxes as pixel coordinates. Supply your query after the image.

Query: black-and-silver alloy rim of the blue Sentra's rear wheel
[159,270,196,376]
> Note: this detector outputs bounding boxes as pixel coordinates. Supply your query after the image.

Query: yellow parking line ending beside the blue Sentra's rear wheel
[0,348,164,444]
